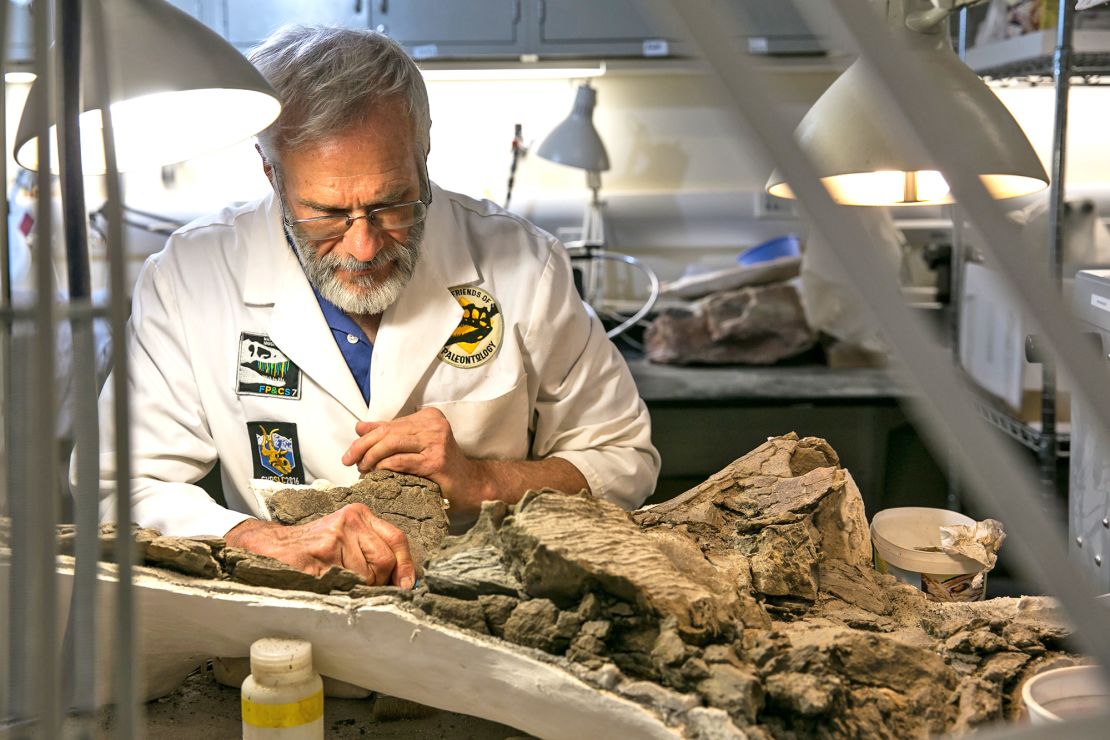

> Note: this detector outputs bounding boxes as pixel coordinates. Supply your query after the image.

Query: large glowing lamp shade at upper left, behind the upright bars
[16,0,281,174]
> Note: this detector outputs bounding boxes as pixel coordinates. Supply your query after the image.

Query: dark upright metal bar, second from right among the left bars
[57,0,100,738]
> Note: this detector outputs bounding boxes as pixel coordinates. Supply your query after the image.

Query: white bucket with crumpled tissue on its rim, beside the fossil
[871,506,987,601]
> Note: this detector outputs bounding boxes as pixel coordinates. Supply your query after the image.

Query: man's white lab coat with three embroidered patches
[100,181,659,536]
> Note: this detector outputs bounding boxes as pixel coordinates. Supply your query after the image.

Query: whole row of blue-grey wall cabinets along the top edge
[145,0,825,60]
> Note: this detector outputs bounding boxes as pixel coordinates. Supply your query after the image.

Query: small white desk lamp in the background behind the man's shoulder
[536,82,609,245]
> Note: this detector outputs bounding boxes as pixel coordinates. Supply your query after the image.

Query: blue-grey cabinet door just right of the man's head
[370,0,531,59]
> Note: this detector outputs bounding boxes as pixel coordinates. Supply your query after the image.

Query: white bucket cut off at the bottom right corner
[1021,666,1110,724]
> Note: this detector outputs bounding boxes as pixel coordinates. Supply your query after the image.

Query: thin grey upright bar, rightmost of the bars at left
[85,2,143,740]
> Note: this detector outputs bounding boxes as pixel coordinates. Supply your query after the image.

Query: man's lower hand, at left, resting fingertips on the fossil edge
[224,504,416,588]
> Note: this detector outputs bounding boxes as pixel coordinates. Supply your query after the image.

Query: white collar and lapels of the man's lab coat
[243,184,481,420]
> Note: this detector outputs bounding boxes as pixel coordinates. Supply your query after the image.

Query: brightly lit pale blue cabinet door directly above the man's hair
[222,0,380,49]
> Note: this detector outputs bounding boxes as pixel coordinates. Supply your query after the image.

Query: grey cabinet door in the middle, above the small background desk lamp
[532,0,676,57]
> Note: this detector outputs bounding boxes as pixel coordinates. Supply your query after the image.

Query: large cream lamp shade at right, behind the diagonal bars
[767,3,1048,205]
